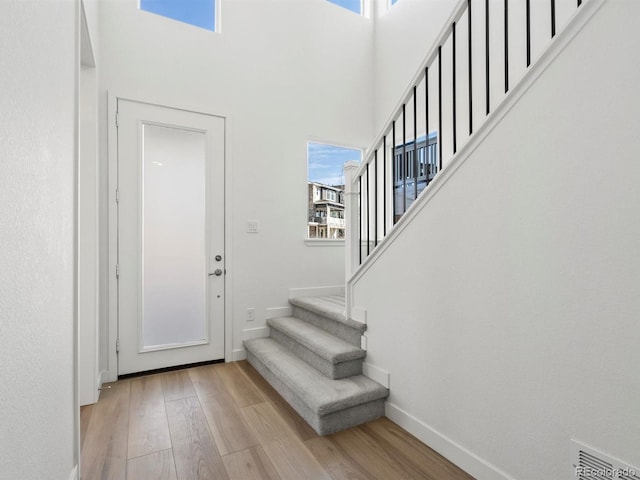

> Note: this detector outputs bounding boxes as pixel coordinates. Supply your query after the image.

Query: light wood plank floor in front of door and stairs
[81,361,473,480]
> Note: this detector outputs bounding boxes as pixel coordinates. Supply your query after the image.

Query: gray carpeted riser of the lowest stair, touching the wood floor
[247,350,384,435]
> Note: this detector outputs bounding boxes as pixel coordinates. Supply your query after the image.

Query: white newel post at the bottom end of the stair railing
[344,160,360,318]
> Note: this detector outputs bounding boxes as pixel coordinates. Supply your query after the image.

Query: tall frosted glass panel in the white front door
[141,125,207,349]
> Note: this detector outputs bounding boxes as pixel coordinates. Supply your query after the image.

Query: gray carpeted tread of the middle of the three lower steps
[267,317,366,365]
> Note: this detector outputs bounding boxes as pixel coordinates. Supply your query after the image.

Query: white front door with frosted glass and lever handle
[117,99,225,375]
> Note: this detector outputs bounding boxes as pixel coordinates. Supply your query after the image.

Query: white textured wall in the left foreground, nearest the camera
[0,0,78,480]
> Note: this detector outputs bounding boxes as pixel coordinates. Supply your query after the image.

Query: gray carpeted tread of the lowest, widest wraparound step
[244,338,389,416]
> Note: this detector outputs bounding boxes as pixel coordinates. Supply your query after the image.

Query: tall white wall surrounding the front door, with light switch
[99,0,373,372]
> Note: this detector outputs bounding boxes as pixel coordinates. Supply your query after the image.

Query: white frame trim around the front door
[106,91,233,382]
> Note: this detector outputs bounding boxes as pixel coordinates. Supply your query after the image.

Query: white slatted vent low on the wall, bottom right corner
[571,440,640,480]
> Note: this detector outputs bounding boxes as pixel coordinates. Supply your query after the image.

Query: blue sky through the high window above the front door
[140,0,216,31]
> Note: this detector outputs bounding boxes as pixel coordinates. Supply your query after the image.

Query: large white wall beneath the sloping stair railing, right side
[354,0,640,480]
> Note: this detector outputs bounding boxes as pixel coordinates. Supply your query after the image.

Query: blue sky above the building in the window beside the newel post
[307,142,362,185]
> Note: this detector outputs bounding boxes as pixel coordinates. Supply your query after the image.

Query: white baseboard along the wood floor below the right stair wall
[385,402,516,480]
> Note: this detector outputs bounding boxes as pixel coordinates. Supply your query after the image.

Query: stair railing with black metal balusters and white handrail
[345,0,583,272]
